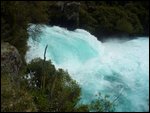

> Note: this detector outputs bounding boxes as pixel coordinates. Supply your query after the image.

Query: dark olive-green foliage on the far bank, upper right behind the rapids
[79,1,149,37]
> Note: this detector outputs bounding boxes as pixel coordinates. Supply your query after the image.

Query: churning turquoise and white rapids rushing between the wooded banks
[26,25,149,112]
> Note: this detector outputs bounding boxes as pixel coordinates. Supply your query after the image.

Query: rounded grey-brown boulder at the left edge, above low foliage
[1,42,22,75]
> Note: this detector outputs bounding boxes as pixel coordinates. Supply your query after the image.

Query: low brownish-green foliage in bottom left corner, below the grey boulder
[1,73,37,112]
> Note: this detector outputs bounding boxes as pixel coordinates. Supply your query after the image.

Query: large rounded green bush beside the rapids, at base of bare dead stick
[27,58,80,112]
